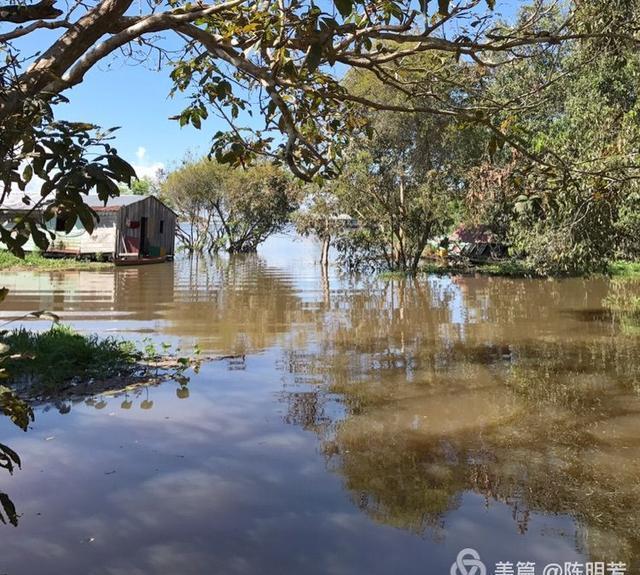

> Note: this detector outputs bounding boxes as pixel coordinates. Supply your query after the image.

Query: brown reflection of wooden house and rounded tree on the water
[0,255,305,356]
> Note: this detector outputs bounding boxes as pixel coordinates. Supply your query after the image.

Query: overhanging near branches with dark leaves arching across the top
[0,0,616,254]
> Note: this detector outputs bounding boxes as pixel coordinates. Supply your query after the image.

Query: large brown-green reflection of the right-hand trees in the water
[282,279,640,561]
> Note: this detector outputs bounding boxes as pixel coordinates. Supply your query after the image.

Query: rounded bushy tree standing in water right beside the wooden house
[162,158,296,253]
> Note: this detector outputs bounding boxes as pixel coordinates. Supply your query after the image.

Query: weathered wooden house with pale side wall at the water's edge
[0,192,177,258]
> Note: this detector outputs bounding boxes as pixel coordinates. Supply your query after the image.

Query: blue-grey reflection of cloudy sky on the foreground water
[0,354,576,575]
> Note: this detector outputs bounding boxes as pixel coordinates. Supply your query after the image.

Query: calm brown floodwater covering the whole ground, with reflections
[0,237,640,575]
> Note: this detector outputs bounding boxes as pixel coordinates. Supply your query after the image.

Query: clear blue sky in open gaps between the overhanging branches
[23,0,523,179]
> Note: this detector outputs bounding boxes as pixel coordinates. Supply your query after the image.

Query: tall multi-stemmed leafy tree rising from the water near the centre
[296,55,484,273]
